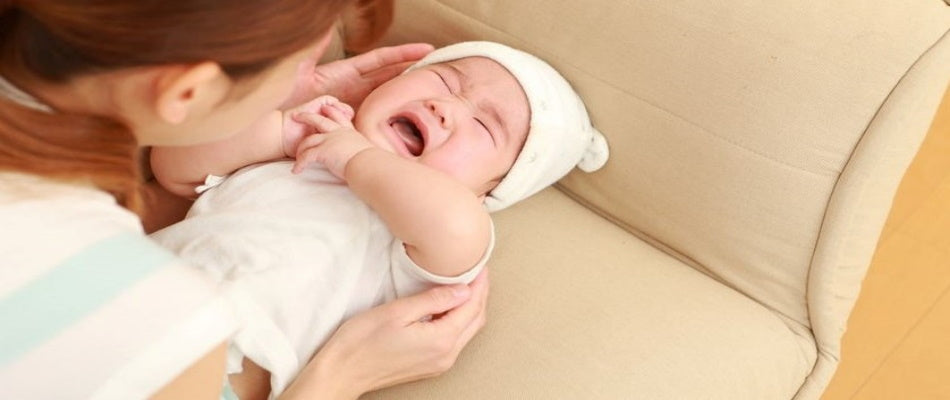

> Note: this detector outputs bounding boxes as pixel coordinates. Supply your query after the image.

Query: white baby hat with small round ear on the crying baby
[407,42,609,212]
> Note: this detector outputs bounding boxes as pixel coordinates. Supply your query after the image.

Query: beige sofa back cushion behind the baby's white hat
[386,0,950,328]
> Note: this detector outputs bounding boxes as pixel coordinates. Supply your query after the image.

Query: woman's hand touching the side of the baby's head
[280,43,432,110]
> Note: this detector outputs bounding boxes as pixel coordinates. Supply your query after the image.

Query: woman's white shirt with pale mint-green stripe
[0,173,236,399]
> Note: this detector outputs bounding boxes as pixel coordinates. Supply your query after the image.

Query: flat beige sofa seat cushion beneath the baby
[366,188,815,400]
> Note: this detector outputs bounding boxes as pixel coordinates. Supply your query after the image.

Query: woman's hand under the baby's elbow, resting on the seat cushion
[281,269,488,399]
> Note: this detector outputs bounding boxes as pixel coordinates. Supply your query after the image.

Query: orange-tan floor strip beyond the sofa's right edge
[823,88,950,400]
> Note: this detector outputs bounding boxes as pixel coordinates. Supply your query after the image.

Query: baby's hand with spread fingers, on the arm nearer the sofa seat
[292,103,373,179]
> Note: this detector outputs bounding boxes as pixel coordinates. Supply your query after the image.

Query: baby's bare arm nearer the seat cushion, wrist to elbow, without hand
[345,148,492,276]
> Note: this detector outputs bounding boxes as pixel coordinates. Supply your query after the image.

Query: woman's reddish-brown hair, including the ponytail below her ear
[0,0,368,216]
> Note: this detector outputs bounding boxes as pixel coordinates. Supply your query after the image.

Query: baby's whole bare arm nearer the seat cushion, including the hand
[294,107,492,277]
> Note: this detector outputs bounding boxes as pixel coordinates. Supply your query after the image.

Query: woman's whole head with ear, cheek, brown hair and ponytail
[0,0,364,212]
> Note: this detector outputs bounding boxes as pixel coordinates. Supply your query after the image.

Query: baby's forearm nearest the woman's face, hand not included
[151,111,285,198]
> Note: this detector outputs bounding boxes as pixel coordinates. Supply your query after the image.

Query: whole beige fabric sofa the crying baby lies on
[342,0,950,400]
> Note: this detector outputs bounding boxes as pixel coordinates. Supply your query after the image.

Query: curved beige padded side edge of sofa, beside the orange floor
[799,34,950,398]
